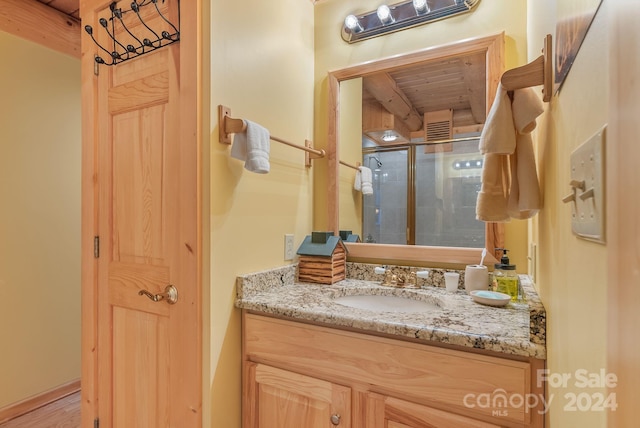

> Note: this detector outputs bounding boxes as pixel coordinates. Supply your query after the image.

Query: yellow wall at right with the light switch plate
[529,0,609,427]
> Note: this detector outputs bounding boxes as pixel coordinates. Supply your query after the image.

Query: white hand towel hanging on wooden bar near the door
[231,120,271,174]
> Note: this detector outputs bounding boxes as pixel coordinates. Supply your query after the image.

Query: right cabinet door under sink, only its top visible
[366,393,499,428]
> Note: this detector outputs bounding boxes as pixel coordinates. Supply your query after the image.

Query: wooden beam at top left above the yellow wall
[0,0,81,59]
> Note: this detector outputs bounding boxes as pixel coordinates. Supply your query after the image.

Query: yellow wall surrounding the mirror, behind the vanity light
[314,0,527,273]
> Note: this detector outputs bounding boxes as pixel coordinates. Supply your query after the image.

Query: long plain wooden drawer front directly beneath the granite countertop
[243,314,533,425]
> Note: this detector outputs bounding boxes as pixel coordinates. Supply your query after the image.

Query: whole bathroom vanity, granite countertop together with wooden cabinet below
[236,263,545,428]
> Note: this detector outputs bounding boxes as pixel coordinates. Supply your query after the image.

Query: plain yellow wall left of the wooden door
[0,32,80,408]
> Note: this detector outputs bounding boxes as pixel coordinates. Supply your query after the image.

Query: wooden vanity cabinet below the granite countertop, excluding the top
[242,311,544,428]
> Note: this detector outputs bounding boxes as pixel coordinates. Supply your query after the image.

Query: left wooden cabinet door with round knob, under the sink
[243,363,351,428]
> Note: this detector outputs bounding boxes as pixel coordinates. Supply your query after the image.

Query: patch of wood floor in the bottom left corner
[0,392,80,428]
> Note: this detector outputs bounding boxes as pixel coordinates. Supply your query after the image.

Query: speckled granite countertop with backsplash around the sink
[236,263,546,359]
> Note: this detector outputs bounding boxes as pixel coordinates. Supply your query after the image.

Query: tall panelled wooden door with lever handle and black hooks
[81,0,202,428]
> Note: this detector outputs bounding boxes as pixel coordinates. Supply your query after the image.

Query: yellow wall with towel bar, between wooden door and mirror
[205,0,316,428]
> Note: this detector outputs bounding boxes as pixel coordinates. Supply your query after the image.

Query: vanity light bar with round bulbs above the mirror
[342,0,480,43]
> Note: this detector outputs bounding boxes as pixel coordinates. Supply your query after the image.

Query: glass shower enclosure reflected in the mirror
[362,135,485,248]
